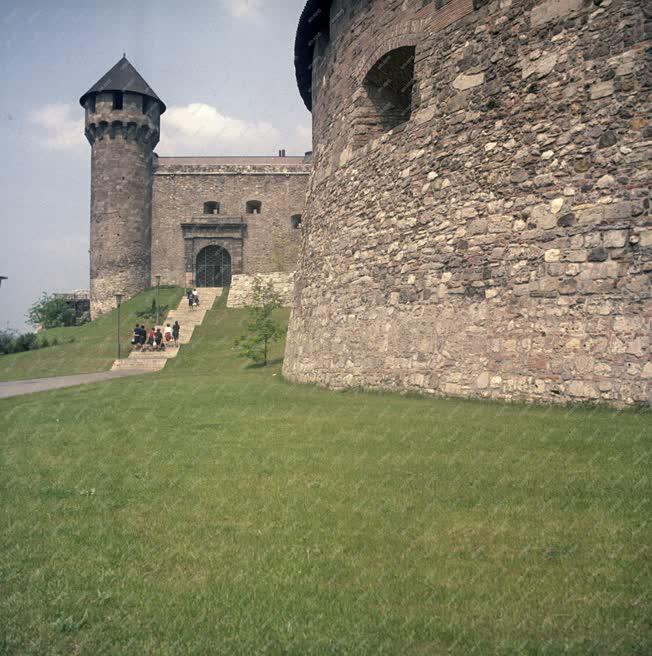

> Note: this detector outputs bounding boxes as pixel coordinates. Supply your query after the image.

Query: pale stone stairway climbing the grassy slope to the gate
[111,287,222,373]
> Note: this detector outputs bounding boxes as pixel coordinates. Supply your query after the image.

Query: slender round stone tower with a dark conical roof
[79,56,165,317]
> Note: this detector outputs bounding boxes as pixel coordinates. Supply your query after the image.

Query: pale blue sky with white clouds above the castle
[0,0,311,330]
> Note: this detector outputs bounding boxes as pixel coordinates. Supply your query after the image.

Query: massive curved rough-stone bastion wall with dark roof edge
[284,0,652,403]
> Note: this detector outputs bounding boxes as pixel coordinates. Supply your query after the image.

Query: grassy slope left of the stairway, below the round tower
[0,287,183,380]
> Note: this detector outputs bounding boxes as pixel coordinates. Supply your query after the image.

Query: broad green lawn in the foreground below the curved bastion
[0,294,652,656]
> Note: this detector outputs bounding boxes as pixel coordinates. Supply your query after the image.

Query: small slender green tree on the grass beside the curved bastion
[235,277,283,367]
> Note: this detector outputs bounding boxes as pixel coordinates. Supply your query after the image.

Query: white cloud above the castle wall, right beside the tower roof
[157,103,280,155]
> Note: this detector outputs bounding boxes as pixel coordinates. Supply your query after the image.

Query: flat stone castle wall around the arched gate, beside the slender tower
[152,157,310,285]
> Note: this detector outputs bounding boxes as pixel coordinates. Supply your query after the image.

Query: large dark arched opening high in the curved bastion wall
[361,46,415,137]
